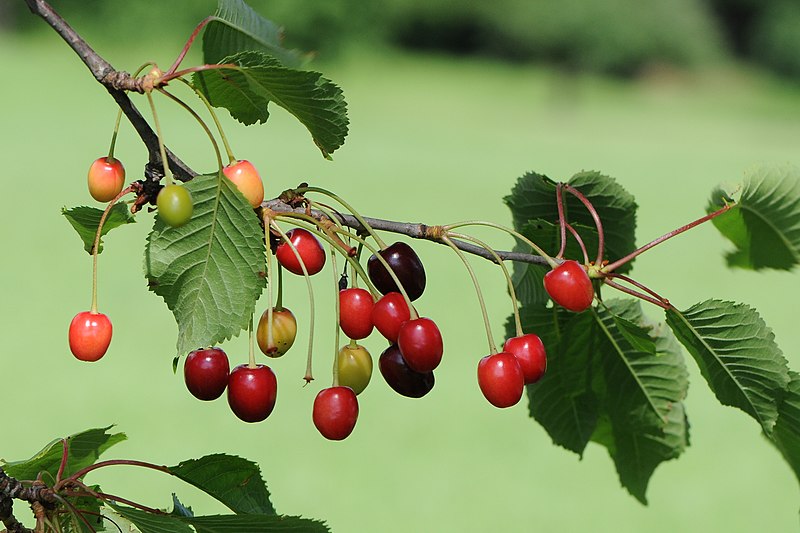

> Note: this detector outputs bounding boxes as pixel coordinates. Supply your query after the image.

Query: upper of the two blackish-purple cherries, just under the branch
[367,242,425,302]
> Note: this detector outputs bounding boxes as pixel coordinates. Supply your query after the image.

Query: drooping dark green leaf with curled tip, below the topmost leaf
[193,52,348,158]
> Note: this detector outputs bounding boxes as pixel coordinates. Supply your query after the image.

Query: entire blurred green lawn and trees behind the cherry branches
[0,0,800,532]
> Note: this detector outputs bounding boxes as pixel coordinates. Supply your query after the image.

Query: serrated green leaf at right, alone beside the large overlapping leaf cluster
[667,300,789,435]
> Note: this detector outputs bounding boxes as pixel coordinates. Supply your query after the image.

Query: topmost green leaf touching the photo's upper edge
[203,0,302,67]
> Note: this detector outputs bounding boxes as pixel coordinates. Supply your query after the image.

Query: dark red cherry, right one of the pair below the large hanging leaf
[228,364,278,422]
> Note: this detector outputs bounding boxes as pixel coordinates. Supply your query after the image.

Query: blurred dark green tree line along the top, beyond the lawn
[6,0,800,77]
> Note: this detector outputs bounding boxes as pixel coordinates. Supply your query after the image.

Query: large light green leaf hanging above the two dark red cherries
[145,174,266,355]
